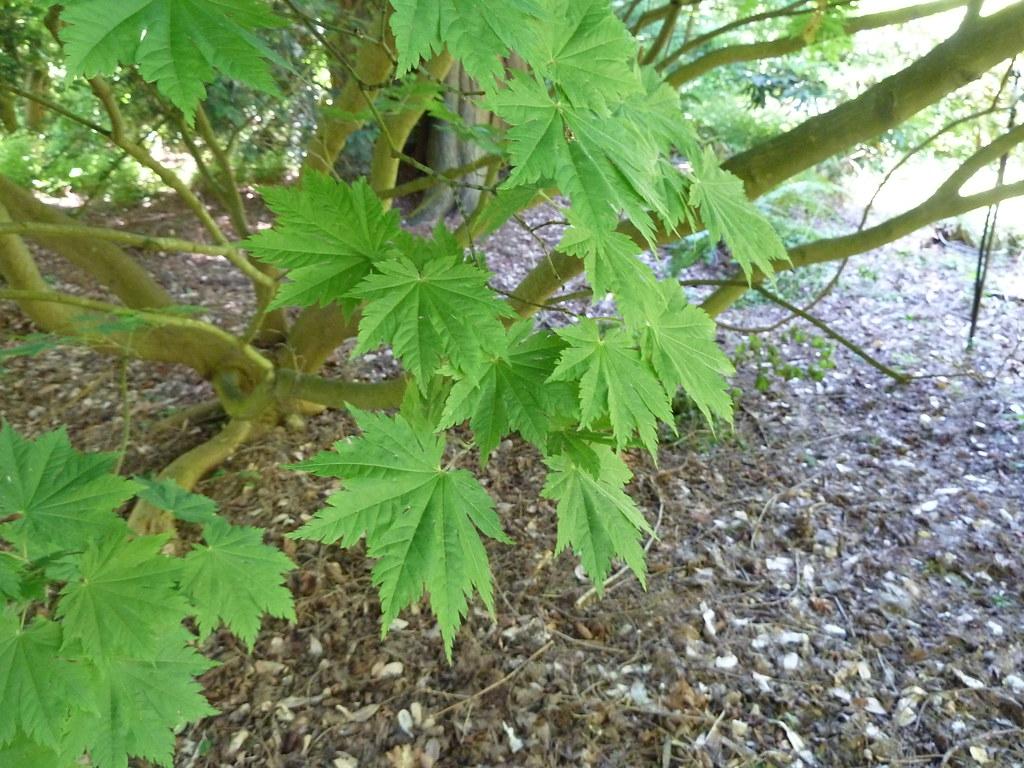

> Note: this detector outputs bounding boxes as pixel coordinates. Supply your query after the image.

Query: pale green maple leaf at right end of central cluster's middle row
[641,281,735,422]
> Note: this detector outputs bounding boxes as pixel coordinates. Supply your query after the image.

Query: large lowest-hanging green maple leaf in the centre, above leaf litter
[292,412,509,659]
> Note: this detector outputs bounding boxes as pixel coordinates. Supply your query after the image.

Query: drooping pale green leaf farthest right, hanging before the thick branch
[690,148,790,279]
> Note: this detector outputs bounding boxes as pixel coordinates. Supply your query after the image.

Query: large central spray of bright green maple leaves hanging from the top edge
[266,0,785,653]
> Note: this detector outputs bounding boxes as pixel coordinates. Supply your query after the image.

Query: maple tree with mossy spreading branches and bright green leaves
[0,0,1024,652]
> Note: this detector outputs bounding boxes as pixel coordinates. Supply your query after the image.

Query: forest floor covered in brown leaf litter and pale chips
[0,199,1024,768]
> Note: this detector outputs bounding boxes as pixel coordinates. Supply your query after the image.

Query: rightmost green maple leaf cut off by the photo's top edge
[521,0,639,106]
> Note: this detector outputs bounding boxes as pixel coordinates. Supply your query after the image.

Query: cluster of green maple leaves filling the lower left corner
[0,424,294,768]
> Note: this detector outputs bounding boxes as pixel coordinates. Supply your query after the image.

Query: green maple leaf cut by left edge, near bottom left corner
[0,611,89,745]
